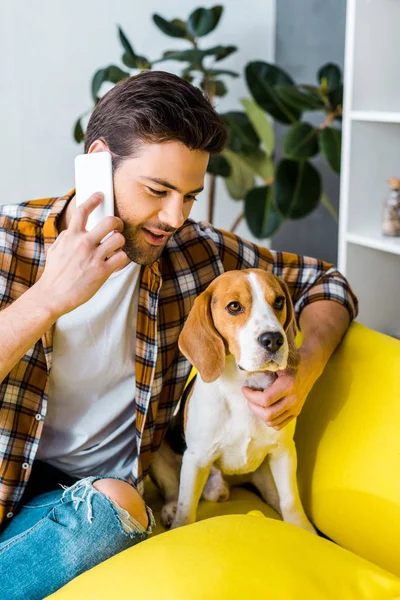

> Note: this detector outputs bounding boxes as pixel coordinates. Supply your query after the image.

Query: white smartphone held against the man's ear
[75,152,114,233]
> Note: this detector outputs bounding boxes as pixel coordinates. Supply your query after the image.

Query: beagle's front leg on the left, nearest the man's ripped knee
[172,450,212,529]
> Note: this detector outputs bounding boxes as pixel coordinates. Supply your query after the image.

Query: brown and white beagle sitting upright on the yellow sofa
[150,269,316,533]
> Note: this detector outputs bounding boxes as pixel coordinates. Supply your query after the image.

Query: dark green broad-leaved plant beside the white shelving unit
[239,61,343,238]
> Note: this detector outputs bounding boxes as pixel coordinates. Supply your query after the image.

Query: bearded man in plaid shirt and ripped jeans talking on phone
[0,71,357,598]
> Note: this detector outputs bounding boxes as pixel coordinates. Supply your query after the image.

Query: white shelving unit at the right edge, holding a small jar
[338,0,400,338]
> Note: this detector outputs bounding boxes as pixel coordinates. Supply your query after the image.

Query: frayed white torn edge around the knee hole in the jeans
[59,477,156,534]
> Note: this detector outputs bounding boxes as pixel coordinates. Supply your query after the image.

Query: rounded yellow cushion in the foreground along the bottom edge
[50,511,400,600]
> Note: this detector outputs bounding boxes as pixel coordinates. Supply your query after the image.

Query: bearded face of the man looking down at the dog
[110,142,209,265]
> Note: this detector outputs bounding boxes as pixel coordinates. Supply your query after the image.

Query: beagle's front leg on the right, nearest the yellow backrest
[269,441,316,533]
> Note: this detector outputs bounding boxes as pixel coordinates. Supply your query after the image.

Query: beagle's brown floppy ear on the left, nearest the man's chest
[178,290,225,383]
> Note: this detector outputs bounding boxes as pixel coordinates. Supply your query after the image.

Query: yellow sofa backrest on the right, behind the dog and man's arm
[295,323,400,576]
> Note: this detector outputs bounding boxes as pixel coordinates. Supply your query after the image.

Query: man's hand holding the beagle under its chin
[242,368,320,430]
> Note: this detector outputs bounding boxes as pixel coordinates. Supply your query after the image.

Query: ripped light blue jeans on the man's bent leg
[0,476,155,600]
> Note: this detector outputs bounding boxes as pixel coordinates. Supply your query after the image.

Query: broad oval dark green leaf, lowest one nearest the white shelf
[274,159,322,219]
